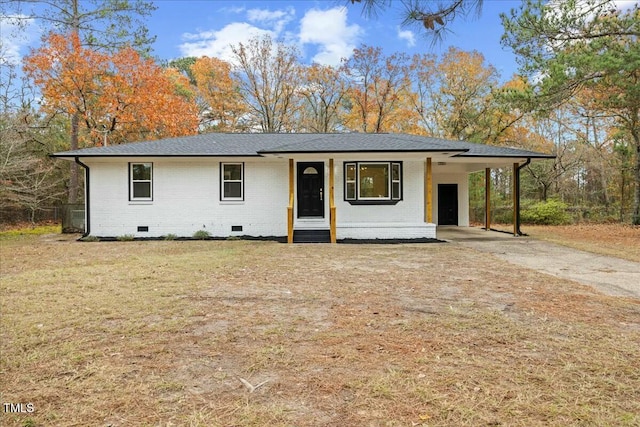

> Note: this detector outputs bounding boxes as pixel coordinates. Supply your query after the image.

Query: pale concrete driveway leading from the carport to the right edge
[437,227,640,299]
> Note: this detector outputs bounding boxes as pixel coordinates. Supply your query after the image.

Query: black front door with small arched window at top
[298,162,324,218]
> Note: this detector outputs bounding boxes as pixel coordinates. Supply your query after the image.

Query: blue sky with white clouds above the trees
[0,0,637,81]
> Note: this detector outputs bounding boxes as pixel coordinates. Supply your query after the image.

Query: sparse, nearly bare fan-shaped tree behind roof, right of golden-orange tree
[231,36,300,132]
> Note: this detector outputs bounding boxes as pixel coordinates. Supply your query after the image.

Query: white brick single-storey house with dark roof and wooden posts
[53,133,553,242]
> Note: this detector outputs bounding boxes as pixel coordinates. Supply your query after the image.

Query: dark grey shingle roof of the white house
[53,133,553,158]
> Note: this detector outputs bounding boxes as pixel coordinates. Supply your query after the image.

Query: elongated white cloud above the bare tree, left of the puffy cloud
[179,22,277,61]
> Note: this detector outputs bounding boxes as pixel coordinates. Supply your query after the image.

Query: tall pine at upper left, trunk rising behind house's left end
[0,0,156,203]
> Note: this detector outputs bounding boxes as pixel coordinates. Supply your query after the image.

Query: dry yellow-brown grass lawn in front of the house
[0,235,640,427]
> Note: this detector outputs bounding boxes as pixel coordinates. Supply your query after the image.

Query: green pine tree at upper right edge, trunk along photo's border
[502,0,640,224]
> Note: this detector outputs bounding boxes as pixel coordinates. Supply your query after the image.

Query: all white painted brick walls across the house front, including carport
[83,158,469,239]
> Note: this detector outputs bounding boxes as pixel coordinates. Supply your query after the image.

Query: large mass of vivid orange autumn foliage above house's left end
[24,33,198,145]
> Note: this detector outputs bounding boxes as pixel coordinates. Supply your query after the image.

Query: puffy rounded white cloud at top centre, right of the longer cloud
[299,7,362,65]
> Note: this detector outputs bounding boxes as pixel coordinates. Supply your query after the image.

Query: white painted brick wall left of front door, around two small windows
[86,159,288,237]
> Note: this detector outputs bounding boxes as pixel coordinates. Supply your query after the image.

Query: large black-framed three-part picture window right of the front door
[344,162,402,204]
